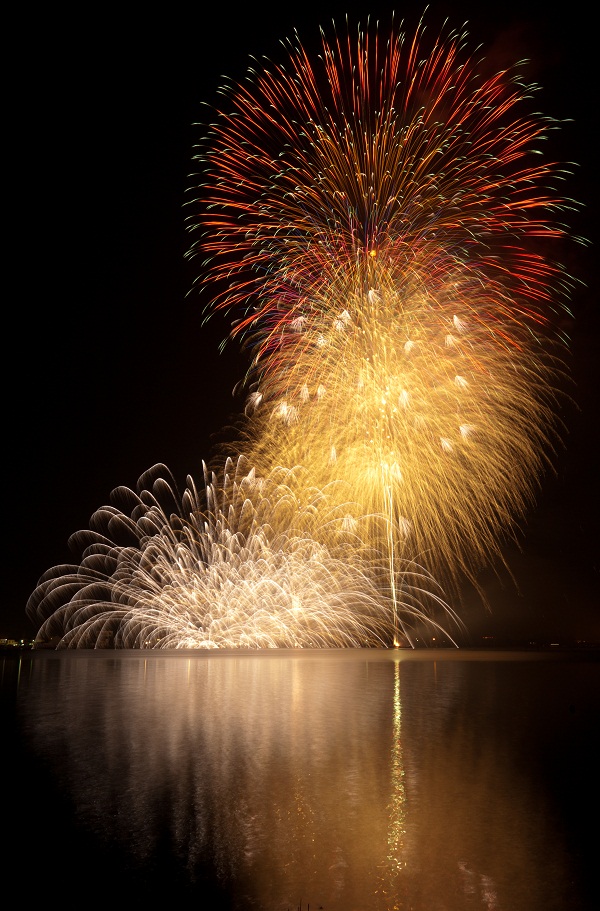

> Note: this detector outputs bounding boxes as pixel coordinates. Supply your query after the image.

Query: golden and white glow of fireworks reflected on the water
[20,650,584,911]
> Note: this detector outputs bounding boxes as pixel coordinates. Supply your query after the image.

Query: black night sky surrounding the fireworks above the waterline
[0,0,600,642]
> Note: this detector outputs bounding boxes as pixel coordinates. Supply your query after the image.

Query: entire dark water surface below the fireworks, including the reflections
[0,650,600,911]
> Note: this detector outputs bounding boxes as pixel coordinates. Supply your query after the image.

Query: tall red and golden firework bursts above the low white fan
[191,16,572,600]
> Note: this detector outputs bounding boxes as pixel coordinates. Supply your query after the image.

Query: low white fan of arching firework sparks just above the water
[27,460,459,648]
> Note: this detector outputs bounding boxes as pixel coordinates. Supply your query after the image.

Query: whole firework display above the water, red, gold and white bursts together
[28,16,573,648]
